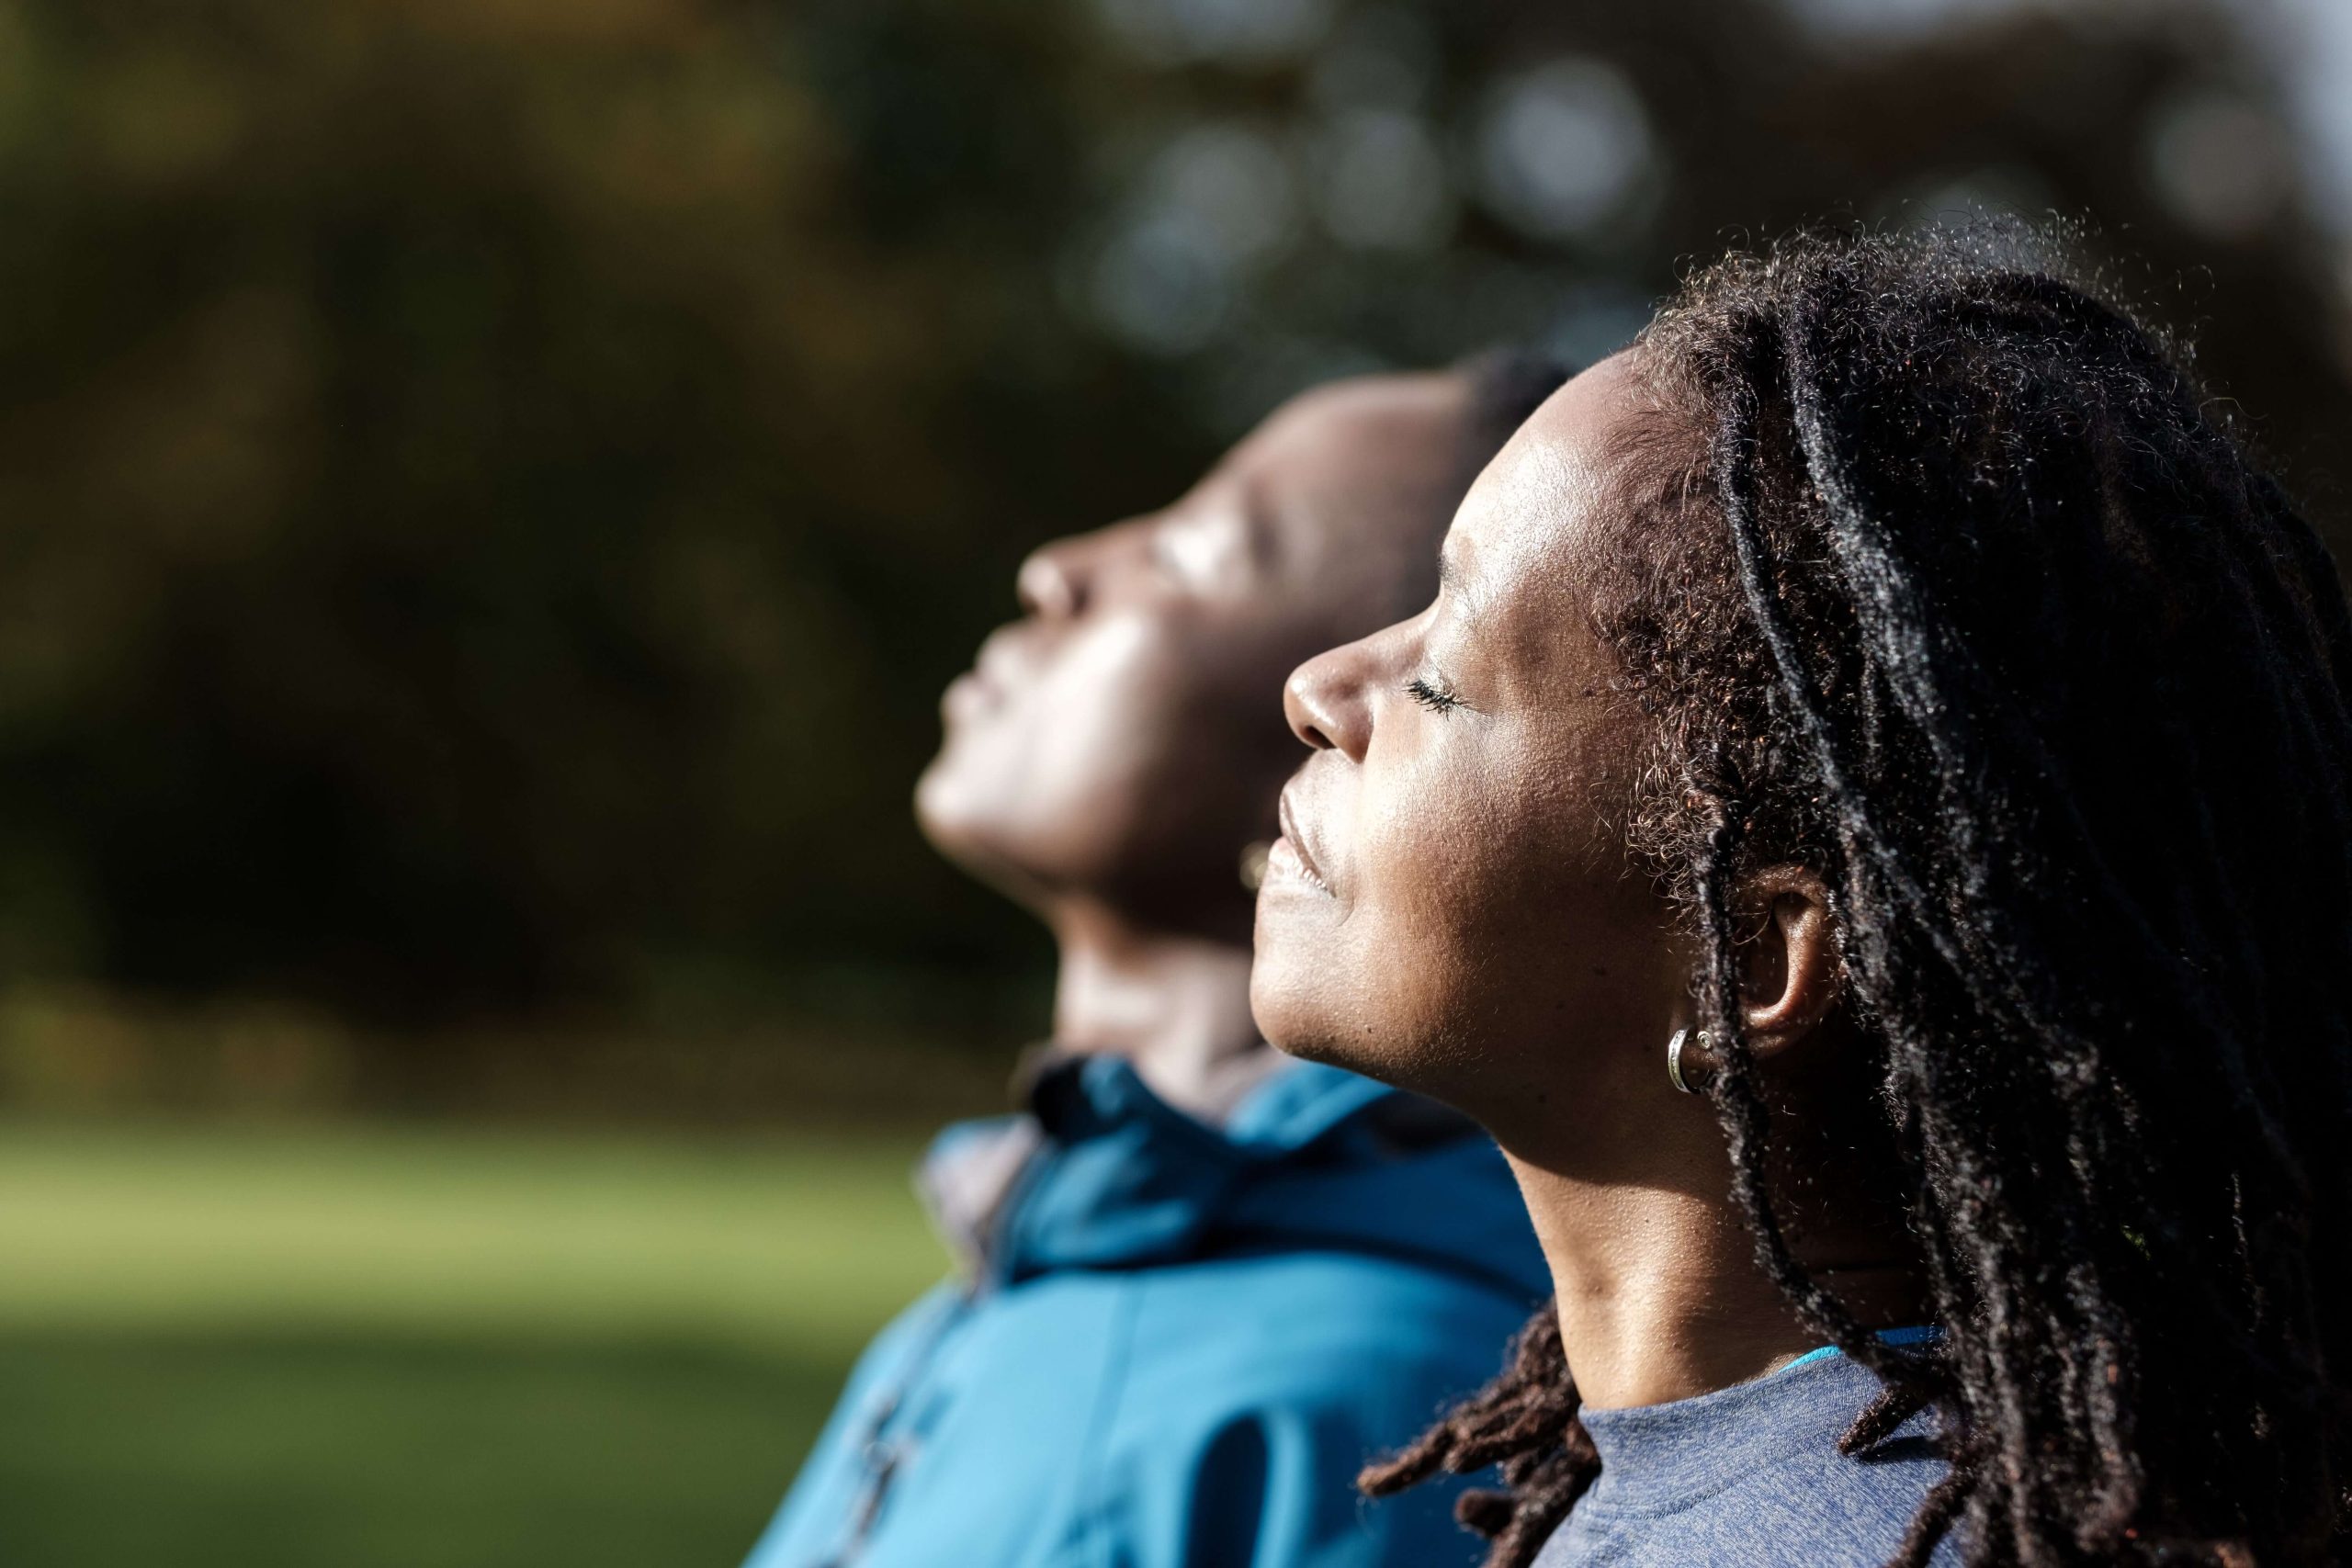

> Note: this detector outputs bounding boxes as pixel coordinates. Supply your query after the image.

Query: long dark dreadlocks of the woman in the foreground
[1364,232,2352,1568]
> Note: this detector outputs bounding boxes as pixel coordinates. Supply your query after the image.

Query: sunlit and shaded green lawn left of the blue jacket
[0,1126,941,1568]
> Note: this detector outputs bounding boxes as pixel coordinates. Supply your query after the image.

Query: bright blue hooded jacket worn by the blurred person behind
[748,1058,1547,1568]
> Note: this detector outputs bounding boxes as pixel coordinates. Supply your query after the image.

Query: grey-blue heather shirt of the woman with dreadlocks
[1536,1352,1962,1568]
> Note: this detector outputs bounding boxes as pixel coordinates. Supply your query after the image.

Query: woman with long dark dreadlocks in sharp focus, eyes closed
[1253,226,2352,1568]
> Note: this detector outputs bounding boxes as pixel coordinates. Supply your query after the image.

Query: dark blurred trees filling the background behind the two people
[0,0,2352,1081]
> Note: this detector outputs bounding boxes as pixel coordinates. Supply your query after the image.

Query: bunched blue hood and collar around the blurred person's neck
[920,1055,1550,1307]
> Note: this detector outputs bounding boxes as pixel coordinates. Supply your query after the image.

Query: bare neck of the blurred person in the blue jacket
[1051,905,1280,1119]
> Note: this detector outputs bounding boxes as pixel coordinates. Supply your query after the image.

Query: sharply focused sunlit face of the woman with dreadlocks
[1251,355,1689,1145]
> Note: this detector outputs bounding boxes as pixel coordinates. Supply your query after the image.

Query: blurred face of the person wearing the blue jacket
[917,374,1473,941]
